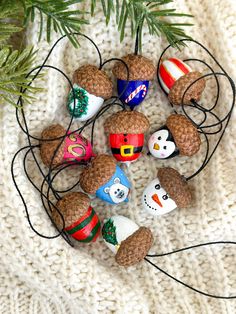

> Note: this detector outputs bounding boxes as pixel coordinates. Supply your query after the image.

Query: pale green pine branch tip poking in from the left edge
[0,47,39,105]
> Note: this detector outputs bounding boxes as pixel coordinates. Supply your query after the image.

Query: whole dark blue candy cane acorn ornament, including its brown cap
[113,54,155,109]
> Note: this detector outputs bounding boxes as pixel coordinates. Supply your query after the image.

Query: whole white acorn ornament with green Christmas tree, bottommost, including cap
[102,216,153,266]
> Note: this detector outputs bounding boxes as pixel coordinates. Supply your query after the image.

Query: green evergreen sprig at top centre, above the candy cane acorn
[91,0,192,51]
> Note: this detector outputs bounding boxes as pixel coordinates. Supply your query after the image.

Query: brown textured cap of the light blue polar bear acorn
[80,154,116,194]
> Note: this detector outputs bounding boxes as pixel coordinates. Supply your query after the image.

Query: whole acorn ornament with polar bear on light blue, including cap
[80,154,131,204]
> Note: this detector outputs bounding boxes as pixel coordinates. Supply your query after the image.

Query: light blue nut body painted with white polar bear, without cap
[96,166,131,204]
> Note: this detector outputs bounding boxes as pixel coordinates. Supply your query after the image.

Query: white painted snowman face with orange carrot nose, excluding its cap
[142,178,177,216]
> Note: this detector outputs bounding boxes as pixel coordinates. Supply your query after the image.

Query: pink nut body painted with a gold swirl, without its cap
[63,133,95,162]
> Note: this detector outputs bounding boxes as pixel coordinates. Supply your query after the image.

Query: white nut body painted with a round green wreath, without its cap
[67,84,104,121]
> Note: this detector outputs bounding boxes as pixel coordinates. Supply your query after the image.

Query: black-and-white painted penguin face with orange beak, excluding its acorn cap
[148,127,178,159]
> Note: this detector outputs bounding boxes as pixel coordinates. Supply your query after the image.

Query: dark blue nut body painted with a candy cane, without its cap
[117,79,149,108]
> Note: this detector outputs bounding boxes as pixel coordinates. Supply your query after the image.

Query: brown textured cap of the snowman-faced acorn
[157,167,192,208]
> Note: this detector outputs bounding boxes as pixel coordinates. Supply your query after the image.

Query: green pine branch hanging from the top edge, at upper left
[21,0,88,47]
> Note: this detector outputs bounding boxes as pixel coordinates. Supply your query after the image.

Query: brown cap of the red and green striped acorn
[52,192,90,229]
